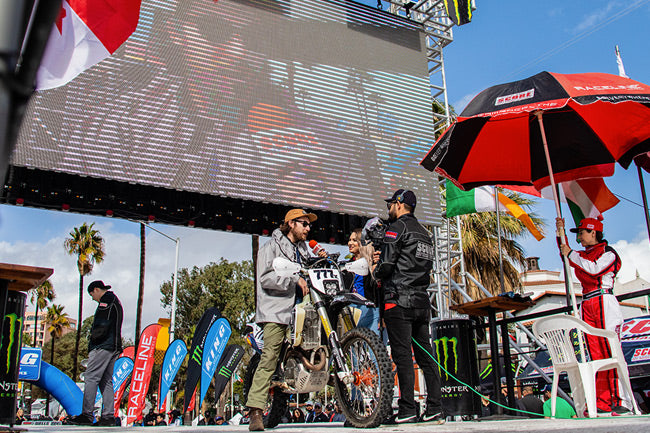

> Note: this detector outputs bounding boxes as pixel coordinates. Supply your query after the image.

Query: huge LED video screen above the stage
[12,0,440,224]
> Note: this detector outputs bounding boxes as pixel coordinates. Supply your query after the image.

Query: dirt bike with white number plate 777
[244,256,394,428]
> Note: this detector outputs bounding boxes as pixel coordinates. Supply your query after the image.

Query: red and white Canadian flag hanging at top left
[36,0,140,90]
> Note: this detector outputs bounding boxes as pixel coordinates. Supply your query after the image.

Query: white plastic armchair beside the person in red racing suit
[533,314,641,418]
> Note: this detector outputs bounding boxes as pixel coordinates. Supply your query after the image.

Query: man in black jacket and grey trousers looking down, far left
[70,280,123,426]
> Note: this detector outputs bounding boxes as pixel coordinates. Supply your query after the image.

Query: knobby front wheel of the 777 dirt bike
[335,328,394,428]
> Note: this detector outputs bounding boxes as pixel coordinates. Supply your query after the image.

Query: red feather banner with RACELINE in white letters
[126,323,161,425]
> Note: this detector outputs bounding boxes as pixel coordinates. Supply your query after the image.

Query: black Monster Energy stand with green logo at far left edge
[0,289,27,424]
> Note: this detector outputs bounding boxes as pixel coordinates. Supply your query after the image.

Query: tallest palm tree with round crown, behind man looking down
[63,223,104,381]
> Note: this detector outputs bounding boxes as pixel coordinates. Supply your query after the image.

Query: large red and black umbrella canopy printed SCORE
[421,72,650,189]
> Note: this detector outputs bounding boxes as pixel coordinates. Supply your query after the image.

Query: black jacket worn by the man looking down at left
[88,290,124,352]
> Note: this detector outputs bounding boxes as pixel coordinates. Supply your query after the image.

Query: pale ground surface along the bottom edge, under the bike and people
[8,416,650,433]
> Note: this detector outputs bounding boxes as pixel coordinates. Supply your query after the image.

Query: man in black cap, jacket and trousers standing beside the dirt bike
[374,189,444,424]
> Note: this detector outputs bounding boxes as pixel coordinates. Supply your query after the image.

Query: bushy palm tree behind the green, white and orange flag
[452,191,544,299]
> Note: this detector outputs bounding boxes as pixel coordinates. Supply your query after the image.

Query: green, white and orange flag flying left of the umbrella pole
[446,180,544,241]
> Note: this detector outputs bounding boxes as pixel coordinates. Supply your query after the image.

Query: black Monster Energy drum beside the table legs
[432,319,481,415]
